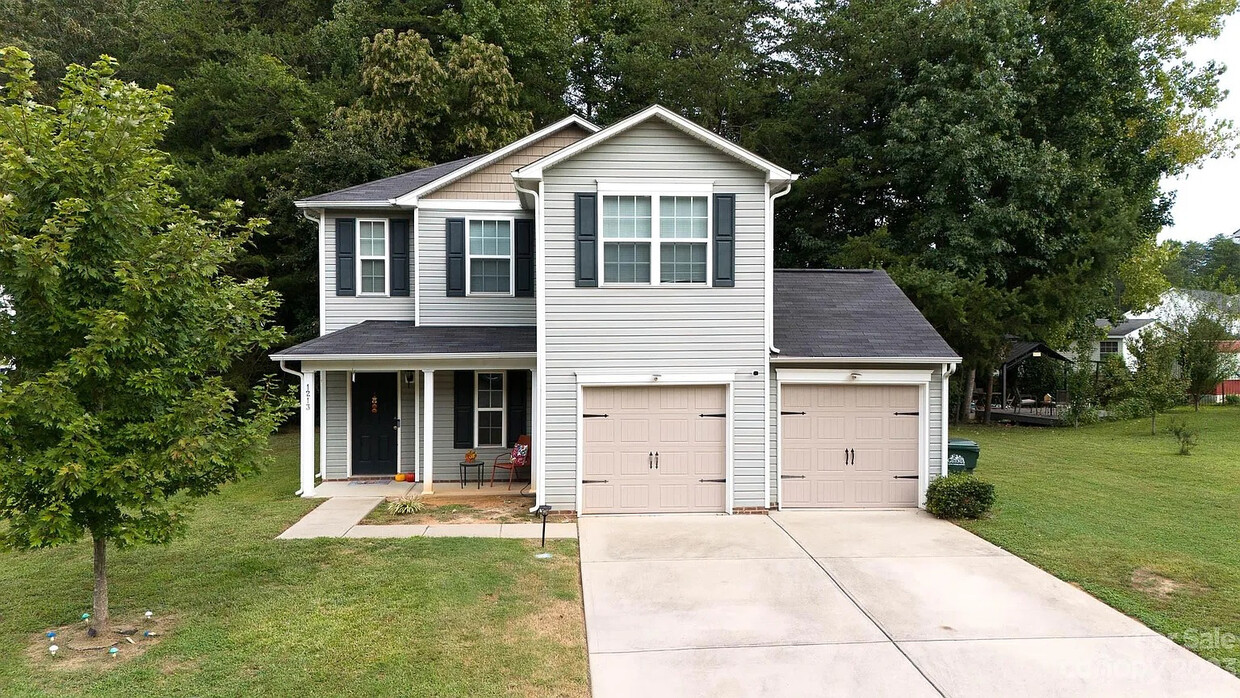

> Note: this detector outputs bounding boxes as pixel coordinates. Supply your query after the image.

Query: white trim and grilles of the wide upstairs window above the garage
[594,190,714,289]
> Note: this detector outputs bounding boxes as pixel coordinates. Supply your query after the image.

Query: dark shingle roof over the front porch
[272,320,537,358]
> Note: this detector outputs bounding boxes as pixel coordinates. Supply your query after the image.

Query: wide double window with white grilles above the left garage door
[599,193,711,285]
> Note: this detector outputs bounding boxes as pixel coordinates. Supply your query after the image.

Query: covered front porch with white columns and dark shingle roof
[273,321,538,497]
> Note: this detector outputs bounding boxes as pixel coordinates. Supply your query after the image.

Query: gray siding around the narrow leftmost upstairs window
[319,210,415,335]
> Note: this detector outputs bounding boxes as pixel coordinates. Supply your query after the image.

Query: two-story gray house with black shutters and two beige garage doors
[273,107,960,513]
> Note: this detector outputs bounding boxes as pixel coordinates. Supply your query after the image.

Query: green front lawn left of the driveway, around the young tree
[0,435,589,697]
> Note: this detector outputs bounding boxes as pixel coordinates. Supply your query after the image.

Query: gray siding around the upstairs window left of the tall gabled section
[418,210,534,325]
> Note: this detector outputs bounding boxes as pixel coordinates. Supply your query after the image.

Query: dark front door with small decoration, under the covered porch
[352,373,399,475]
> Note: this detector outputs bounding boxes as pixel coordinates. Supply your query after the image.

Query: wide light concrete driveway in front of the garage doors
[578,511,1240,698]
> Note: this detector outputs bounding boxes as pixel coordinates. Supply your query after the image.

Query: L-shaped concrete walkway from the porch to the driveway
[277,496,577,541]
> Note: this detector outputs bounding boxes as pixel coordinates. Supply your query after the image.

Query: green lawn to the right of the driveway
[952,407,1240,673]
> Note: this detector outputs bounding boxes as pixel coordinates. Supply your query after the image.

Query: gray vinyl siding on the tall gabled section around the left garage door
[543,121,766,508]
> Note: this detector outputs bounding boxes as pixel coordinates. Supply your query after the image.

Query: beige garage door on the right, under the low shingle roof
[780,384,921,507]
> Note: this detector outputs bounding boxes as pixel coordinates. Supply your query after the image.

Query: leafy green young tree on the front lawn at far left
[0,47,293,631]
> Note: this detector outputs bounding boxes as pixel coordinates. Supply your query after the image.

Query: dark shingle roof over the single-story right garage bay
[775,269,956,358]
